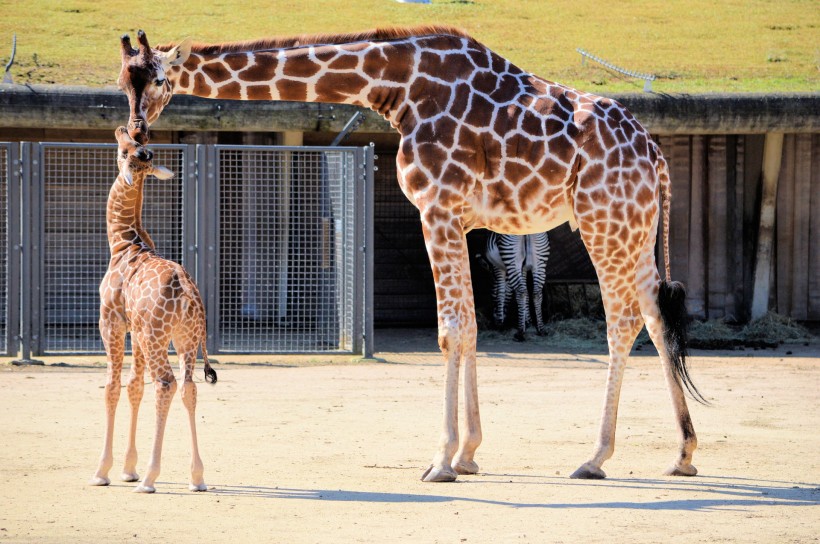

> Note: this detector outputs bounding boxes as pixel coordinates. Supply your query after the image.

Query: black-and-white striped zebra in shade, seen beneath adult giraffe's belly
[485,232,550,342]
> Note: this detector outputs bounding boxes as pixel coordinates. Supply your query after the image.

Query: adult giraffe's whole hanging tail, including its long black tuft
[653,142,709,405]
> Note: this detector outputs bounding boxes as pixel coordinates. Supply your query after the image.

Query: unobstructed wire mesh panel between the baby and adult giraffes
[215,146,360,353]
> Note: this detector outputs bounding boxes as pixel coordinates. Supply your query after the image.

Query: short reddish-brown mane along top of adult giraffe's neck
[156,25,471,55]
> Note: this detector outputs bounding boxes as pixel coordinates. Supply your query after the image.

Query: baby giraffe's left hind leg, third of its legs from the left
[134,344,177,493]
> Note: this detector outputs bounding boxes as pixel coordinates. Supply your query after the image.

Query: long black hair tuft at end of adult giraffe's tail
[658,281,709,405]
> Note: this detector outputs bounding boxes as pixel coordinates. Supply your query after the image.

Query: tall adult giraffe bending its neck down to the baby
[119,27,702,481]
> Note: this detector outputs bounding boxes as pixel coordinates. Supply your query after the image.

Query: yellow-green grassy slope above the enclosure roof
[0,0,820,92]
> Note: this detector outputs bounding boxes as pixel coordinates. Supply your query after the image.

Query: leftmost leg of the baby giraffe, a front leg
[89,311,125,486]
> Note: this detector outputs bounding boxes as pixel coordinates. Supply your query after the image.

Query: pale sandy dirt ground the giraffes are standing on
[0,331,820,543]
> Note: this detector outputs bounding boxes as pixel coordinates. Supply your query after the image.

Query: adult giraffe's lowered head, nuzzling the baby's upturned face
[117,30,191,144]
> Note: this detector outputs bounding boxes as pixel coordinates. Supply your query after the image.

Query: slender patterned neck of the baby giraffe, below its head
[106,175,154,257]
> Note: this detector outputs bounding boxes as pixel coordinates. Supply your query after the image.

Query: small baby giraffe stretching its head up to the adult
[91,127,216,493]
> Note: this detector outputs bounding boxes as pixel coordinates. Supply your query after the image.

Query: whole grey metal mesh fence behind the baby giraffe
[0,142,373,358]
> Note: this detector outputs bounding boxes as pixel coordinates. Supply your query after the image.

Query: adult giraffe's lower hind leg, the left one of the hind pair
[570,301,642,479]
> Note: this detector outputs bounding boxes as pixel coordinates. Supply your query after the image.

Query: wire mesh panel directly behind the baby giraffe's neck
[36,144,188,354]
